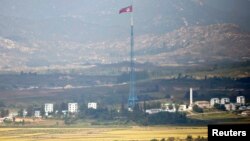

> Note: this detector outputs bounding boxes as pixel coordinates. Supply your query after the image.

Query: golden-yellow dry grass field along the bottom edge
[0,126,207,141]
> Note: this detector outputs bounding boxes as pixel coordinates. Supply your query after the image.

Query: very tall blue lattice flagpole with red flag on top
[119,3,138,110]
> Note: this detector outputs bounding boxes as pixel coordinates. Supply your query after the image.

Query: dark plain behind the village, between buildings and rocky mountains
[0,70,250,108]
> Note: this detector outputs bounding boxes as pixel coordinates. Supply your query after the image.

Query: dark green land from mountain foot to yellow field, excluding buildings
[0,70,250,125]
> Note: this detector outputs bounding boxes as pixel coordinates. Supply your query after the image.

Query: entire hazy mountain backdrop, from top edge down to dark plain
[0,0,250,71]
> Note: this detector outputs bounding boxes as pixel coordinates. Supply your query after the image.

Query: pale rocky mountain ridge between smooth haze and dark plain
[0,24,250,70]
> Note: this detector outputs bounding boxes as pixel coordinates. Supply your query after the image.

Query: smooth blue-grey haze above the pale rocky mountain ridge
[0,0,250,41]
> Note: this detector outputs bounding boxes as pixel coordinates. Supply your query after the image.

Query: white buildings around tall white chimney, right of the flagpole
[145,88,250,114]
